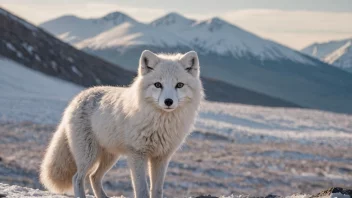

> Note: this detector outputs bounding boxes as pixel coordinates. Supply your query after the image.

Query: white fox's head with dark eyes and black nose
[138,50,203,112]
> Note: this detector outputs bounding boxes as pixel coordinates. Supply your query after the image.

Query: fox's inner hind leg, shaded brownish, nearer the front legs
[89,151,119,198]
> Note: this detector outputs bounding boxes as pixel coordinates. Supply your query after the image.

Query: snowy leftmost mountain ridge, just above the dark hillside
[40,12,137,43]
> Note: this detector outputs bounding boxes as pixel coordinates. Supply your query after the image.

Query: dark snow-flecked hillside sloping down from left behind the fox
[0,8,299,107]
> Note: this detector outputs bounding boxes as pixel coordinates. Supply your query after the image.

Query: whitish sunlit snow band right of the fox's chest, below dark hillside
[196,102,352,146]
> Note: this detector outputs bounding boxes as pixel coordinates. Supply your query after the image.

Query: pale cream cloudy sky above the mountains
[0,0,352,50]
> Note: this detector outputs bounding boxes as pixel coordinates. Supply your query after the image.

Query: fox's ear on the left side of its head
[138,50,159,76]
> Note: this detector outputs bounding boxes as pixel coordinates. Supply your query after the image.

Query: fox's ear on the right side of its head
[180,51,199,77]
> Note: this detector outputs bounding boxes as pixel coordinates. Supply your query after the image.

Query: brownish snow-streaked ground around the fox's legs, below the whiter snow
[0,122,352,197]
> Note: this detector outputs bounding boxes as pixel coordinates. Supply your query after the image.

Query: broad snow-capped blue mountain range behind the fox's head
[40,12,352,113]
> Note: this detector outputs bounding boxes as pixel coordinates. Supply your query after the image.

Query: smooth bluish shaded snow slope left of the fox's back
[0,56,83,123]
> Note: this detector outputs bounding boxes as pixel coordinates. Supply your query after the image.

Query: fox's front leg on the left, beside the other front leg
[127,153,149,198]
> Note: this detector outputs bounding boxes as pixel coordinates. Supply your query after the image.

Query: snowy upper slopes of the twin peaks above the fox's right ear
[151,14,314,64]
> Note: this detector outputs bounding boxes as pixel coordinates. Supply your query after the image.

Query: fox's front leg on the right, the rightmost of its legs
[149,157,169,198]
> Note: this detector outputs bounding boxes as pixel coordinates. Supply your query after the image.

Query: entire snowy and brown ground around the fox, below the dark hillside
[0,59,352,197]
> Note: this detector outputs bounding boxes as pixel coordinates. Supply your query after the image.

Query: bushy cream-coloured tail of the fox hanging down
[40,126,77,193]
